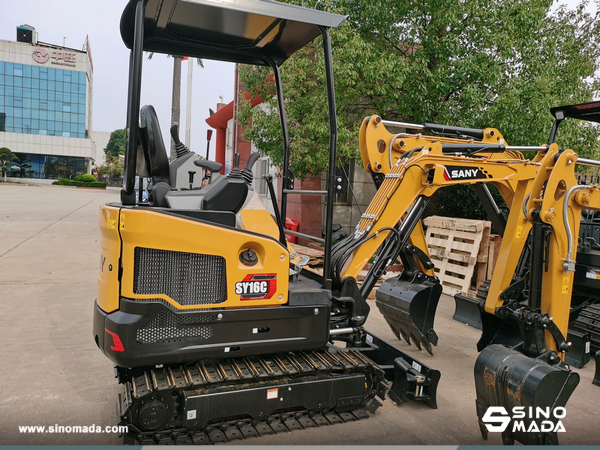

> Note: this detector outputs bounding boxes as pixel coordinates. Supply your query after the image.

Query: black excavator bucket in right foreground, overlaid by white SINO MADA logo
[475,344,579,445]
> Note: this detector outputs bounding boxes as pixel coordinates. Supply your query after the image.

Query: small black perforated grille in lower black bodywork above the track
[136,309,216,344]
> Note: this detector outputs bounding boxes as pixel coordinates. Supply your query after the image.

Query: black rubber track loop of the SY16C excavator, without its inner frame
[117,348,385,445]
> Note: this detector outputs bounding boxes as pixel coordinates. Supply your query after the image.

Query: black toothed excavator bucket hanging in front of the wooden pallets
[376,276,442,355]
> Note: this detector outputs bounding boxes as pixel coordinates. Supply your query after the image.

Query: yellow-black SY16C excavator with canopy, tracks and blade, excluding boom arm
[94,0,440,444]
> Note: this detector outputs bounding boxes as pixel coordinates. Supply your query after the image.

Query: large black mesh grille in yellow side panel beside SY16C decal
[133,247,227,306]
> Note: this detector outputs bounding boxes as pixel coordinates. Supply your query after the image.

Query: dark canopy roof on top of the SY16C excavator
[121,0,346,65]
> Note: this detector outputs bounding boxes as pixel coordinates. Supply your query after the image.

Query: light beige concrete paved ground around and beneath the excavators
[0,184,600,445]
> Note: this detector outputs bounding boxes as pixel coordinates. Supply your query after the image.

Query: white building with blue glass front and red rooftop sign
[0,26,97,180]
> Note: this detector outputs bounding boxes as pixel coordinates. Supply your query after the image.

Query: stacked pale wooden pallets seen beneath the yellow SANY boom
[423,216,491,295]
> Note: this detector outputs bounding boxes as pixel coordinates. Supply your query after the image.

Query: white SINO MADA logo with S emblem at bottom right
[481,406,567,433]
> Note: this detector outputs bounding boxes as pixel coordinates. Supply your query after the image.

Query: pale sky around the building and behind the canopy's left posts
[0,0,234,159]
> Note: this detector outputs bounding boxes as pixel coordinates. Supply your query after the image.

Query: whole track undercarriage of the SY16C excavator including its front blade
[116,334,440,445]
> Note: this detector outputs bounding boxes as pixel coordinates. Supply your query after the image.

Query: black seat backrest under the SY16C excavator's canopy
[140,105,171,185]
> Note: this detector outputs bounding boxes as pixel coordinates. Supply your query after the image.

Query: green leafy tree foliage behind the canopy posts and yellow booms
[238,0,600,176]
